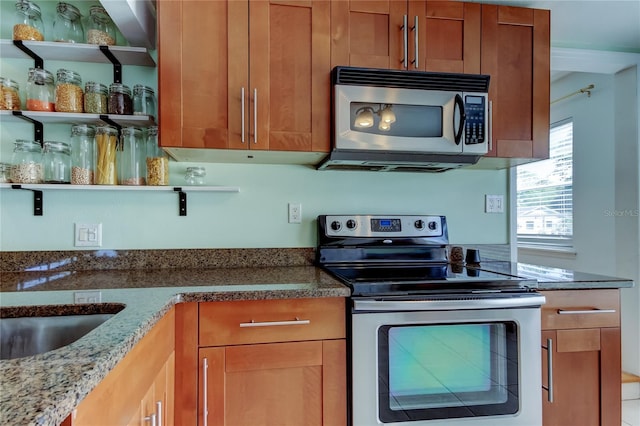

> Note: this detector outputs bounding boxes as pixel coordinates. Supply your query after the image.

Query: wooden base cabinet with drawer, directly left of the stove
[176,298,347,426]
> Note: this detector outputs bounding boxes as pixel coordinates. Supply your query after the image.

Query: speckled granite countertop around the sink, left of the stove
[0,266,350,426]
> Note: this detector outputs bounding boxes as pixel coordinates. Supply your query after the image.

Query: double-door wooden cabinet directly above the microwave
[331,0,481,73]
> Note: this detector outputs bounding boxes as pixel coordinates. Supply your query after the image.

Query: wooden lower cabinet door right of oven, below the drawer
[542,328,622,426]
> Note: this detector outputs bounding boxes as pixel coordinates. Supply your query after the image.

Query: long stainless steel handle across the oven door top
[353,294,545,312]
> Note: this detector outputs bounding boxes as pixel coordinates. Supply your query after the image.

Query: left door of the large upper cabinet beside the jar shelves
[157,0,249,148]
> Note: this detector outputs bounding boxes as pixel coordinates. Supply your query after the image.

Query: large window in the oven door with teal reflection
[378,322,519,422]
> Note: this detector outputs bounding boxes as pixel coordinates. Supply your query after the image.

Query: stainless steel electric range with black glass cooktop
[316,215,544,426]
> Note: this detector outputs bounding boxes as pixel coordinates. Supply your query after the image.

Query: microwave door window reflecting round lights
[350,102,443,138]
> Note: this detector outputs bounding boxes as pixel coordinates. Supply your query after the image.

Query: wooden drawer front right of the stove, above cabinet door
[540,289,620,330]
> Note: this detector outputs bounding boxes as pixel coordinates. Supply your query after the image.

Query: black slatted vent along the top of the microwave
[332,67,489,93]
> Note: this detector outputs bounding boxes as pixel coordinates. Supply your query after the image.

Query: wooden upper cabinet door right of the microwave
[481,4,550,158]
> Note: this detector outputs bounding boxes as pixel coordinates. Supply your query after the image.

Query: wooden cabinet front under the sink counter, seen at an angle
[66,309,175,426]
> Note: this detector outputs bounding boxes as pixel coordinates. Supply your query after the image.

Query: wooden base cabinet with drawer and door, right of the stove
[541,289,622,426]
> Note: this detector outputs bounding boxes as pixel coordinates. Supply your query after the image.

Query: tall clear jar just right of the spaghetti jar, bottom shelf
[118,127,147,185]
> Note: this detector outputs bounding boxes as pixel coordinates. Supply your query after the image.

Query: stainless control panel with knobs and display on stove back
[319,215,445,238]
